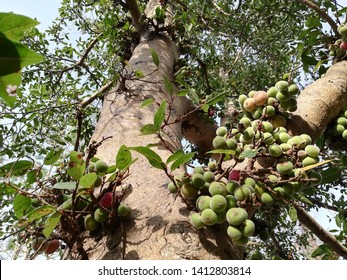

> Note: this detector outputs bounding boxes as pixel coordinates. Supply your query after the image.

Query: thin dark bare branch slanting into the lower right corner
[292,201,347,259]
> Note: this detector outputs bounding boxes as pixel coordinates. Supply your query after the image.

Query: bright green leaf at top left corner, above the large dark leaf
[0,13,39,41]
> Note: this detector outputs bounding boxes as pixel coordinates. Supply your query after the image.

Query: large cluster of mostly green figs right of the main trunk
[168,80,322,246]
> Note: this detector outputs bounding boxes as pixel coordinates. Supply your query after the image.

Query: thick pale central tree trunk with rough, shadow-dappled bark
[75,31,241,259]
